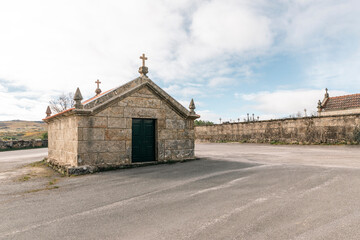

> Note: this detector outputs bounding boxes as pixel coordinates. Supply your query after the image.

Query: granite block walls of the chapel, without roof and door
[48,86,195,168]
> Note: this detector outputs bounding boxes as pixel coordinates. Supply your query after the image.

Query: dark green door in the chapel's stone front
[132,118,155,162]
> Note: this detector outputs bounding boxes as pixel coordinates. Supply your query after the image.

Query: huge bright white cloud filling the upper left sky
[0,1,190,91]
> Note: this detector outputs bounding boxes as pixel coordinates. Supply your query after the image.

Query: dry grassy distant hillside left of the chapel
[0,120,47,140]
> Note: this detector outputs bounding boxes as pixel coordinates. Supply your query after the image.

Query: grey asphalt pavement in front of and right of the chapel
[0,144,360,240]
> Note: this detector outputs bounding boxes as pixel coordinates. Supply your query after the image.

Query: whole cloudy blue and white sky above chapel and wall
[0,0,360,123]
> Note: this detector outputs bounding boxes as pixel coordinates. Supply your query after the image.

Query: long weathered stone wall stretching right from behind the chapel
[195,114,360,144]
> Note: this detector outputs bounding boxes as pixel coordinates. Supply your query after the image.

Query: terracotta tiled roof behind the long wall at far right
[324,94,360,111]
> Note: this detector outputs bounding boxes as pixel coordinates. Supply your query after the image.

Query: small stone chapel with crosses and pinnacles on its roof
[43,54,200,174]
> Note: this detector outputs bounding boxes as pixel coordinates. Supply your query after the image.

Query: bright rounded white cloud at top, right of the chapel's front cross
[183,0,272,60]
